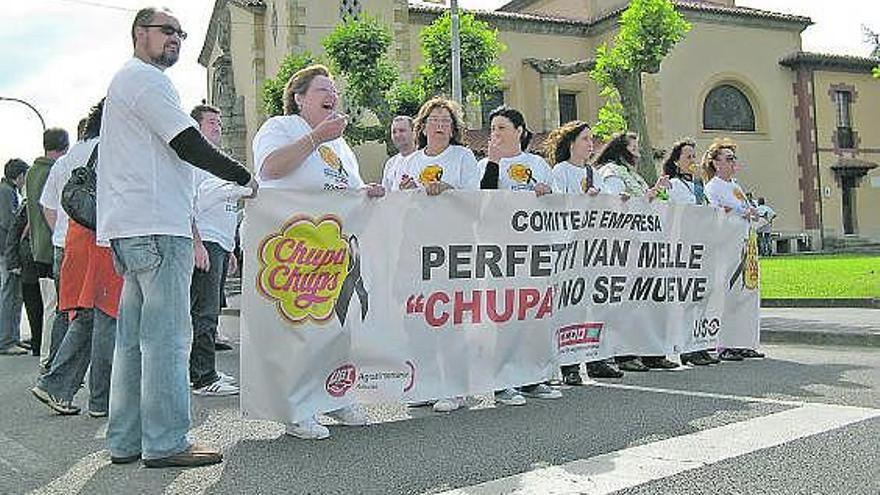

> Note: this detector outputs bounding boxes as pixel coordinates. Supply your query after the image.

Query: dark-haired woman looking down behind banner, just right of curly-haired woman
[596,132,678,371]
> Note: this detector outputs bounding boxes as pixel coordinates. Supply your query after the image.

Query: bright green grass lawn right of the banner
[760,254,880,299]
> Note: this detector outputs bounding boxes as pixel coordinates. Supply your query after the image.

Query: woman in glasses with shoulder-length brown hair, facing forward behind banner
[398,96,480,412]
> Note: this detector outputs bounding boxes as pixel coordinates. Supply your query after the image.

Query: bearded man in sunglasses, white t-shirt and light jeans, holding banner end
[97,8,257,468]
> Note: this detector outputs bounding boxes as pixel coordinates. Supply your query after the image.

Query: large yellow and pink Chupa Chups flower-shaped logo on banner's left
[257,215,369,325]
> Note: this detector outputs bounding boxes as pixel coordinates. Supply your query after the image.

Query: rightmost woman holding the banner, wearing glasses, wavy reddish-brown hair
[703,138,764,361]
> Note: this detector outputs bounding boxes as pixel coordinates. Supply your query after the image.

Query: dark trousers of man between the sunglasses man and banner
[189,241,229,388]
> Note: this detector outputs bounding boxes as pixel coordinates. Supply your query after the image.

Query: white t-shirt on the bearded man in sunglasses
[97,58,198,243]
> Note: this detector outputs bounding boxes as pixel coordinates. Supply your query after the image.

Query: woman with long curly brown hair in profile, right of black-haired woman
[544,121,623,386]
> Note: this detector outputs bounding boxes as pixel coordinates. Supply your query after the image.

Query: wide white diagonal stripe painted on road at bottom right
[443,404,880,495]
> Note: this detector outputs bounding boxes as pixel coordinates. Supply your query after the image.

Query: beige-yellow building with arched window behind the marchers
[199,0,880,250]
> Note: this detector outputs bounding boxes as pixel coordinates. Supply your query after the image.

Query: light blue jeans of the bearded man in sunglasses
[107,235,193,459]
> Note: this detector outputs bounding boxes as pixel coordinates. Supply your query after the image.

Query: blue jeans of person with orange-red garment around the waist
[39,309,116,411]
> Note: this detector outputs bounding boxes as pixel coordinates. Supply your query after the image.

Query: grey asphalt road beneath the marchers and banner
[0,317,880,495]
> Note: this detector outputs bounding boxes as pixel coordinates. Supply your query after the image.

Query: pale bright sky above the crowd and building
[0,0,880,163]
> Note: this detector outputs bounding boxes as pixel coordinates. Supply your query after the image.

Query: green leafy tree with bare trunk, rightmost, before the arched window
[590,0,691,182]
